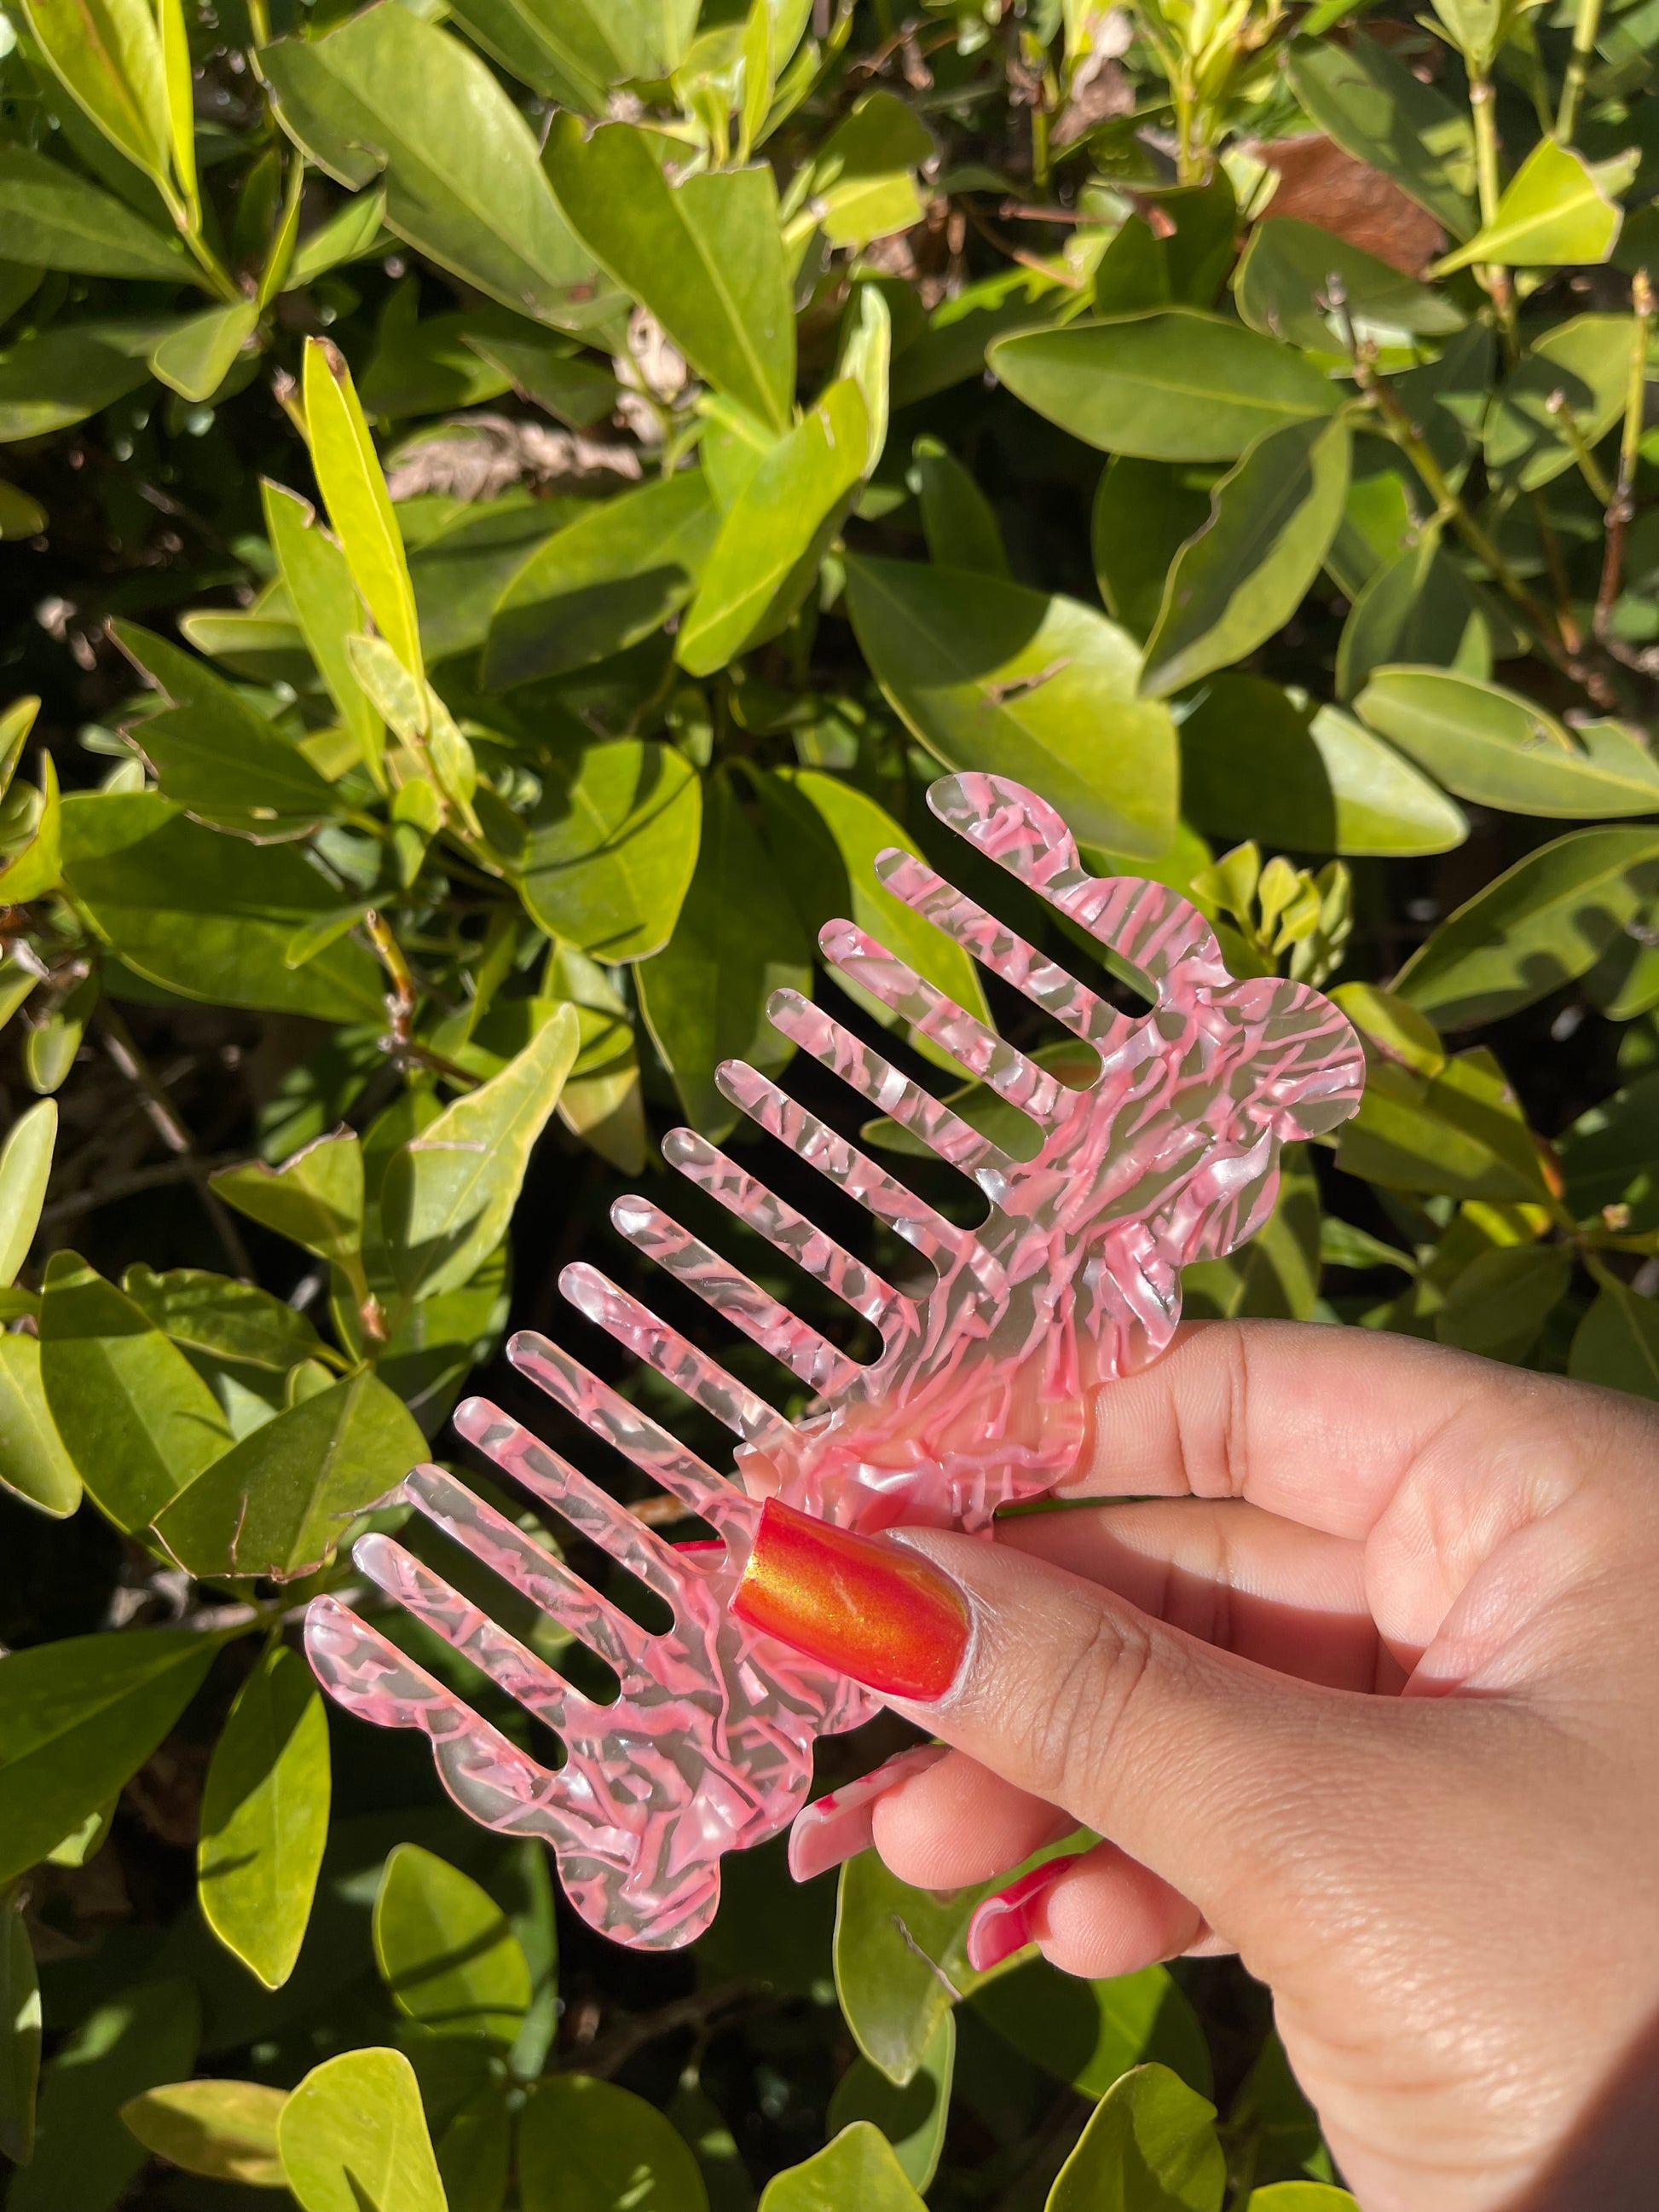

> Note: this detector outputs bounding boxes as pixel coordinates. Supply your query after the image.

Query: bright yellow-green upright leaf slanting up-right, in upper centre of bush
[674,378,870,677]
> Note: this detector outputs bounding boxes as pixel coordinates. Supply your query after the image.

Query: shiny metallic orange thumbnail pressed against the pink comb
[732,1498,968,1703]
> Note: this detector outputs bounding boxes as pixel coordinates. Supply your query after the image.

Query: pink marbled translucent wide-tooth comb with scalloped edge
[305,774,1365,1949]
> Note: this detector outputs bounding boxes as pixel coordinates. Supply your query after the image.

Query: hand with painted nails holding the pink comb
[739,1323,1659,2212]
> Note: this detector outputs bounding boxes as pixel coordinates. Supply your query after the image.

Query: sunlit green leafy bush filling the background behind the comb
[0,0,1659,2212]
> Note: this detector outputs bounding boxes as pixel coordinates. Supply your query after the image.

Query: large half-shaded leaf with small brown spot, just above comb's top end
[847,555,1176,858]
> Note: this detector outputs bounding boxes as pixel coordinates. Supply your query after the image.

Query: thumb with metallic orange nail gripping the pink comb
[732,1499,1444,1964]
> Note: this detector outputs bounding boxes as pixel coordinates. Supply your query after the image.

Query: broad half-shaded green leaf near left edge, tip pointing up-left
[40,1252,230,1530]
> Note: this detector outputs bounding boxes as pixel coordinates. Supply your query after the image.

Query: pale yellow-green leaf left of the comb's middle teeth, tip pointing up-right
[380,1007,580,1298]
